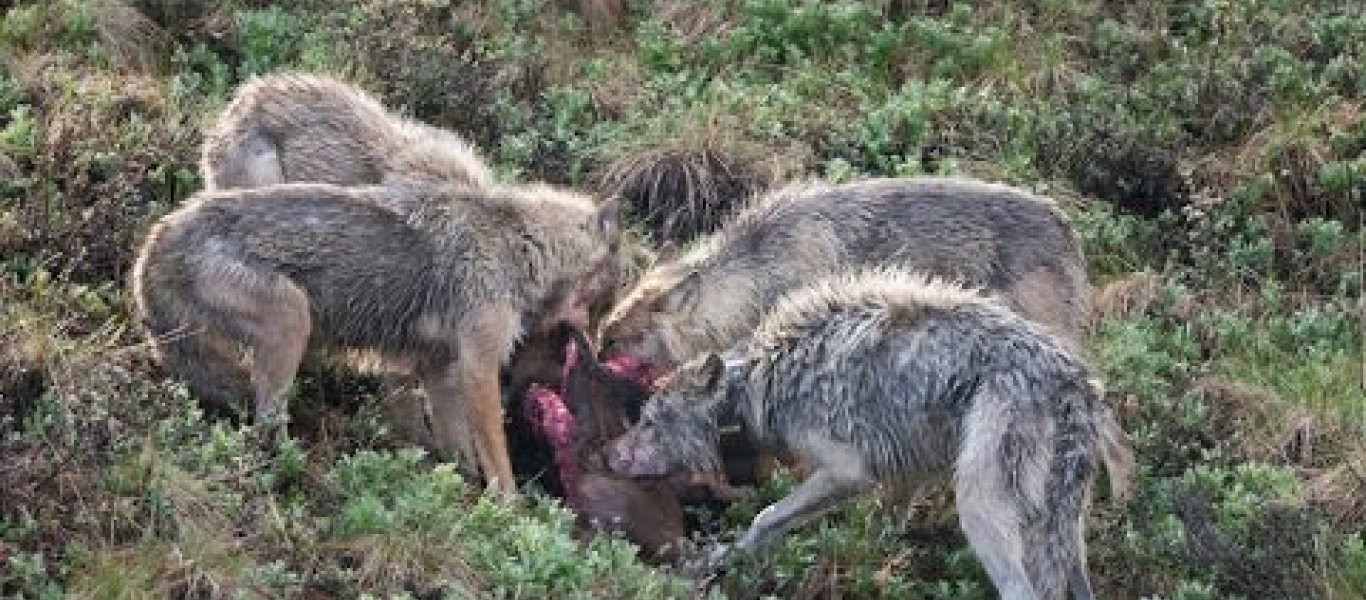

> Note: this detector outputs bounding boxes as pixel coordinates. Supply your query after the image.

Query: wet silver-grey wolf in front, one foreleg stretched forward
[608,268,1105,600]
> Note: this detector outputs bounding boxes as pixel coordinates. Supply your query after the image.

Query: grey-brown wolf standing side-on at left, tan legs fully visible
[131,183,619,493]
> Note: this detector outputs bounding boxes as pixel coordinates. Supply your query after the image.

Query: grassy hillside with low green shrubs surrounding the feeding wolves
[0,0,1366,600]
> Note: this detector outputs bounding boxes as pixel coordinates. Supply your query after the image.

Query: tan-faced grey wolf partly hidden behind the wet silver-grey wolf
[601,176,1134,499]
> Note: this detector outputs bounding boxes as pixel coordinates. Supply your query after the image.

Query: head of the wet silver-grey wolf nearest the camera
[607,354,738,477]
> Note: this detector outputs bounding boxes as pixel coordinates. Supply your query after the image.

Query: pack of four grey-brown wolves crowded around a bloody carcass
[130,72,1134,600]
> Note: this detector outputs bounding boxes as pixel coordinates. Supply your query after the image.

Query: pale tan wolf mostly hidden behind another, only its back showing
[199,72,493,189]
